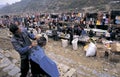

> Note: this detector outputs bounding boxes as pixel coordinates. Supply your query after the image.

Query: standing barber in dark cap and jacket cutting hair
[9,24,38,77]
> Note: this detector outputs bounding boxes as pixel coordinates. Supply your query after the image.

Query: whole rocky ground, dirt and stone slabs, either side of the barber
[0,29,120,77]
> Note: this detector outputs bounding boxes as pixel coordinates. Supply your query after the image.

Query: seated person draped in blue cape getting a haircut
[30,37,59,77]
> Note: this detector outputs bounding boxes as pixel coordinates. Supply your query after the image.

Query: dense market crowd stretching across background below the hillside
[0,12,117,40]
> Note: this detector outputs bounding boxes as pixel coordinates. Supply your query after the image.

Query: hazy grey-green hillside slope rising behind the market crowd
[0,0,120,13]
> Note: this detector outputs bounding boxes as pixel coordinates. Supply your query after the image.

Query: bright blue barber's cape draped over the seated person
[30,46,60,77]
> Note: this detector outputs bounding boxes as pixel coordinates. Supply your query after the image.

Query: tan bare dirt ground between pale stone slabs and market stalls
[0,29,120,77]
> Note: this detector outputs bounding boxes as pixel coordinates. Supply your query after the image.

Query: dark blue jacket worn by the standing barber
[11,29,35,59]
